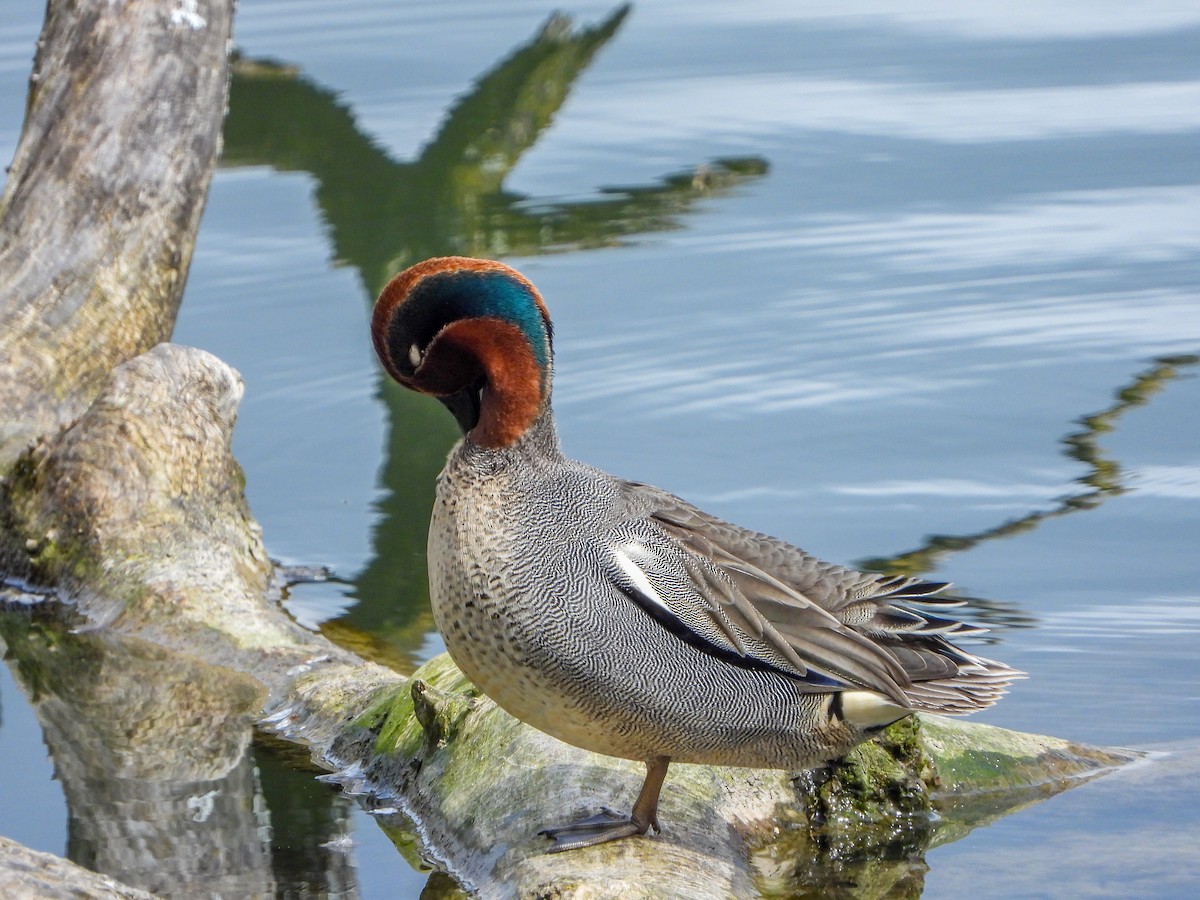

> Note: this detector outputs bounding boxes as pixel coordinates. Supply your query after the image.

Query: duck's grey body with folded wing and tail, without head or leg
[430,412,1015,768]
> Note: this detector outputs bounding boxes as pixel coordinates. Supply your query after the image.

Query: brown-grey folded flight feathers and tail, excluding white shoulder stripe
[638,498,1024,715]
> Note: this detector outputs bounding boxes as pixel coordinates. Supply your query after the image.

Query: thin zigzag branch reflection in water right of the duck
[858,355,1200,628]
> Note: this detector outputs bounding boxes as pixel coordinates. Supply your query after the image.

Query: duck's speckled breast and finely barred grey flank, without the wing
[430,418,851,767]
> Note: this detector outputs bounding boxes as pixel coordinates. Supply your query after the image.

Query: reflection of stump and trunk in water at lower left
[0,604,355,896]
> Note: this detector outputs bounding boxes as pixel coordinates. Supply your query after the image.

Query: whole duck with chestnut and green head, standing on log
[371,257,1024,851]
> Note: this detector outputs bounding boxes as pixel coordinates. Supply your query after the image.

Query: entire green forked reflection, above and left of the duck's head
[222,6,767,668]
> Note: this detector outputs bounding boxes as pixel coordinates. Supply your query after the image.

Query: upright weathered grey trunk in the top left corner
[0,0,233,472]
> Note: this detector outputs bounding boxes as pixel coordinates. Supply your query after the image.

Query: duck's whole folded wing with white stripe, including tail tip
[610,482,1020,713]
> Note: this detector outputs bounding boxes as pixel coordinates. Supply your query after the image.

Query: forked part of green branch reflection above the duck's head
[222,6,767,289]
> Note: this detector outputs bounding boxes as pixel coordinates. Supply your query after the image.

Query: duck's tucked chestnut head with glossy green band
[371,257,553,449]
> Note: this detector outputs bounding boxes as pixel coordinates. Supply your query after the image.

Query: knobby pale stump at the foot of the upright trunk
[0,344,402,691]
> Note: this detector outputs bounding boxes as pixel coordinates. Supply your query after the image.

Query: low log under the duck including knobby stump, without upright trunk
[0,344,1132,896]
